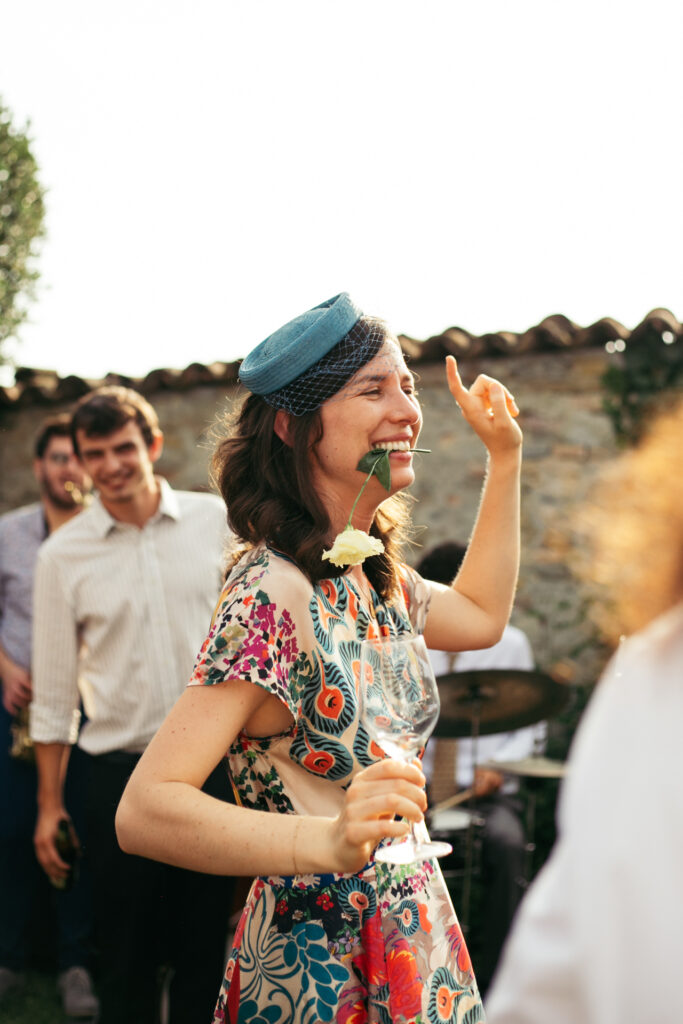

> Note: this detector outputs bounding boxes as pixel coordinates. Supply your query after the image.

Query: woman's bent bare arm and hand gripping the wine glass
[116,680,426,876]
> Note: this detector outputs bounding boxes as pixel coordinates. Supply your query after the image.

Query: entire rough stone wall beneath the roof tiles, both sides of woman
[0,347,616,684]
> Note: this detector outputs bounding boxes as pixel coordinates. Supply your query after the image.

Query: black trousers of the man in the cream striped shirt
[87,753,233,1024]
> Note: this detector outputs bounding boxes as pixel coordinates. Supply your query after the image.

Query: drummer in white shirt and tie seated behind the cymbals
[417,541,547,996]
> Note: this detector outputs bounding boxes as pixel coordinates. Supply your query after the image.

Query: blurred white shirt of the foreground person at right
[486,615,683,1024]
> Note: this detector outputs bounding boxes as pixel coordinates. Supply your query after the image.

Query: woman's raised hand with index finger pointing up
[445,355,522,456]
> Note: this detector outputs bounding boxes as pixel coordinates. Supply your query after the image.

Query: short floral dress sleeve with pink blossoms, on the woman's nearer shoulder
[188,573,300,717]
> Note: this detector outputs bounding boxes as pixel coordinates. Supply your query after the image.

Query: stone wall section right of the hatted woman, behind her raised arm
[414,349,616,684]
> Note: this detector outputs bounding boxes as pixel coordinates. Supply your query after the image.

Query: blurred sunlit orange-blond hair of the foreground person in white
[580,400,683,641]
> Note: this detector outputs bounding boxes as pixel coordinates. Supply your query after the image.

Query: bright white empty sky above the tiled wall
[0,0,683,385]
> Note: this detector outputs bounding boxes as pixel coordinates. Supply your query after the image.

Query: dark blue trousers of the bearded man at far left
[0,705,92,971]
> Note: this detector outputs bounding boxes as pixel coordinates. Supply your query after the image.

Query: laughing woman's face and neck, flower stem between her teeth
[311,339,422,530]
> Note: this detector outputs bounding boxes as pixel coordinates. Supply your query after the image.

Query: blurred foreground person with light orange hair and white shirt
[487,395,683,1024]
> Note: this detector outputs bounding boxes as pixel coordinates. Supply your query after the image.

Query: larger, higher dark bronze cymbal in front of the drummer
[434,669,569,738]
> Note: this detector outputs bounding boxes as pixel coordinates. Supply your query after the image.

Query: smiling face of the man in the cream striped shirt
[77,420,162,506]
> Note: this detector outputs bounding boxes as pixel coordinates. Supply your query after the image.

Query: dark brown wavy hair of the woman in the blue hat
[211,394,410,598]
